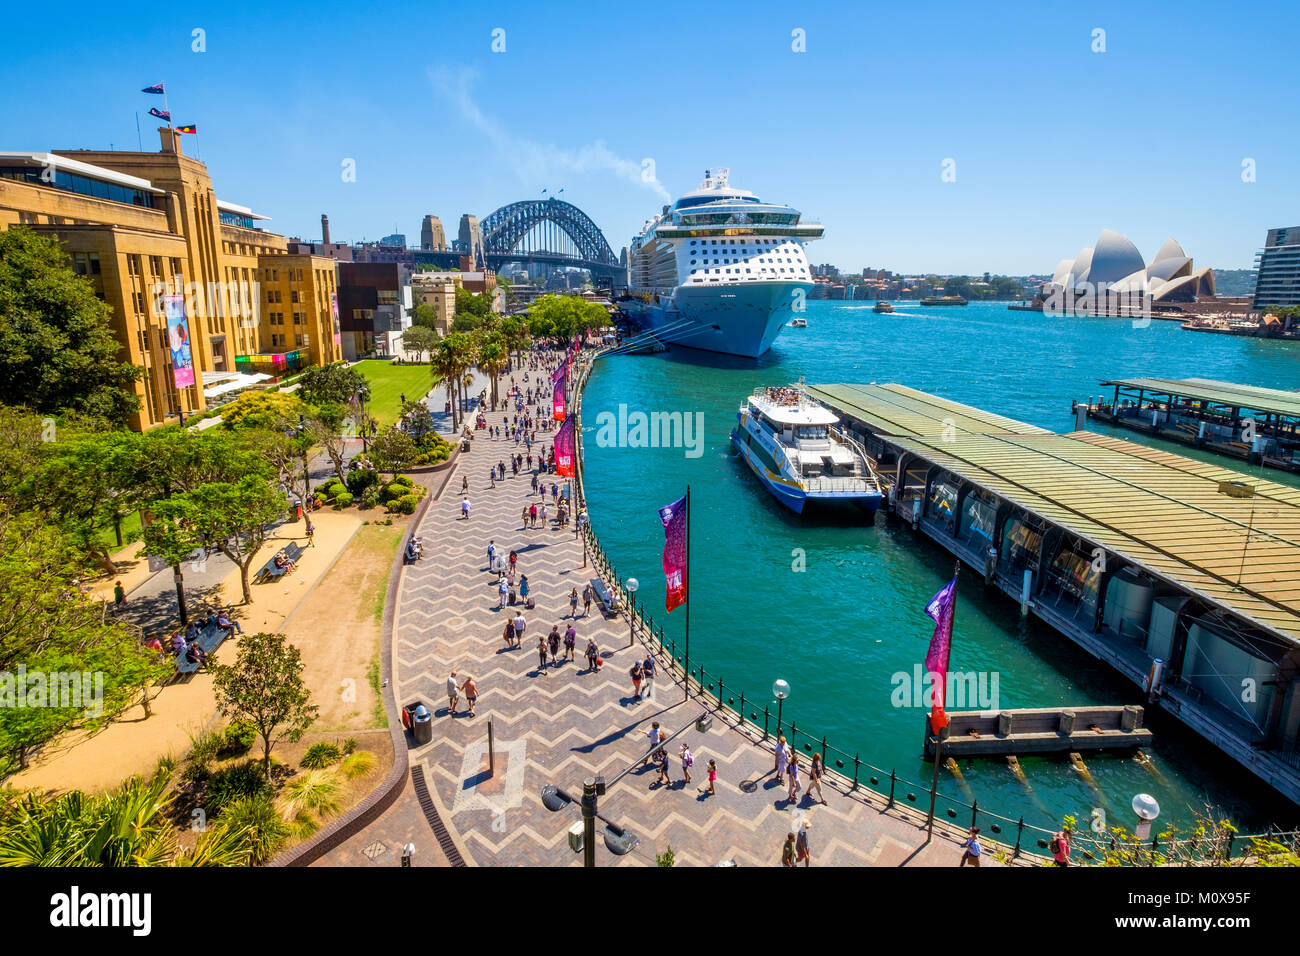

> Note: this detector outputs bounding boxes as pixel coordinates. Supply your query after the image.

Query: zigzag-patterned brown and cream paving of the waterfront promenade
[321,382,993,866]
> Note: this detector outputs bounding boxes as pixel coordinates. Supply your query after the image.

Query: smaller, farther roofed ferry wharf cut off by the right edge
[1074,378,1300,471]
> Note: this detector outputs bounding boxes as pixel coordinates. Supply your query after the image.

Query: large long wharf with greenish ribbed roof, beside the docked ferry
[807,385,1300,803]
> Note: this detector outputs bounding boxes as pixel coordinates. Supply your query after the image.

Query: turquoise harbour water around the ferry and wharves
[582,302,1300,827]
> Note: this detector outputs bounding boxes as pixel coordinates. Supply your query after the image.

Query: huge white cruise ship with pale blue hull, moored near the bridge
[627,169,823,358]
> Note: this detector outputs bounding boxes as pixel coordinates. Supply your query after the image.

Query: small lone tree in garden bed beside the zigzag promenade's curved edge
[212,632,319,779]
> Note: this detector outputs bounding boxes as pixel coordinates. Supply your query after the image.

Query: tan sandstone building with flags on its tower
[0,127,342,431]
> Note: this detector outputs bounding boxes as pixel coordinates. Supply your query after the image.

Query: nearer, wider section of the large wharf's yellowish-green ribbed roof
[889,432,1300,644]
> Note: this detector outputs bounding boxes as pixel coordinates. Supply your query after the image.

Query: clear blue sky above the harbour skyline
[0,0,1300,273]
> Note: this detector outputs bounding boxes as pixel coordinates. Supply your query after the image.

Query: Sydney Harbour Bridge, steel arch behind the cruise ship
[416,196,627,287]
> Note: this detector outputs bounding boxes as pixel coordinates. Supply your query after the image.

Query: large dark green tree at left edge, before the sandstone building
[0,226,143,425]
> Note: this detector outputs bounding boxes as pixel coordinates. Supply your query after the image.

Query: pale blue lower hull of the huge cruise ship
[628,282,813,359]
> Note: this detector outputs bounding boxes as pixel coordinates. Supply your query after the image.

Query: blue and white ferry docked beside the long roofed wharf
[731,388,881,514]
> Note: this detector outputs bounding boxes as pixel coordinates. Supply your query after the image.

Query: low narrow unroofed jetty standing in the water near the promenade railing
[924,705,1152,760]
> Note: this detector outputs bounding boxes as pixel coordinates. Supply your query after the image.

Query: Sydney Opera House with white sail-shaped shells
[1043,229,1214,312]
